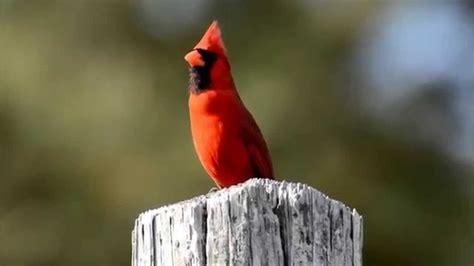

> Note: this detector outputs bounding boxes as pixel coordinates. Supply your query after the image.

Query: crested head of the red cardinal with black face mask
[184,21,233,93]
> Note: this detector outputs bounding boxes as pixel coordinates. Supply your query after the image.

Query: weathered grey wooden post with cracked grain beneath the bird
[132,179,362,266]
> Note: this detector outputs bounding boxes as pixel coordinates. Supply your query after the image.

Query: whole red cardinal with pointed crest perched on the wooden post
[184,21,273,188]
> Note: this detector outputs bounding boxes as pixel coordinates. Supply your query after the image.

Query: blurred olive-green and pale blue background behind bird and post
[0,0,474,266]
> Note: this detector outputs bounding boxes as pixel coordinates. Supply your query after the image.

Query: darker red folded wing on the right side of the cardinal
[242,110,273,179]
